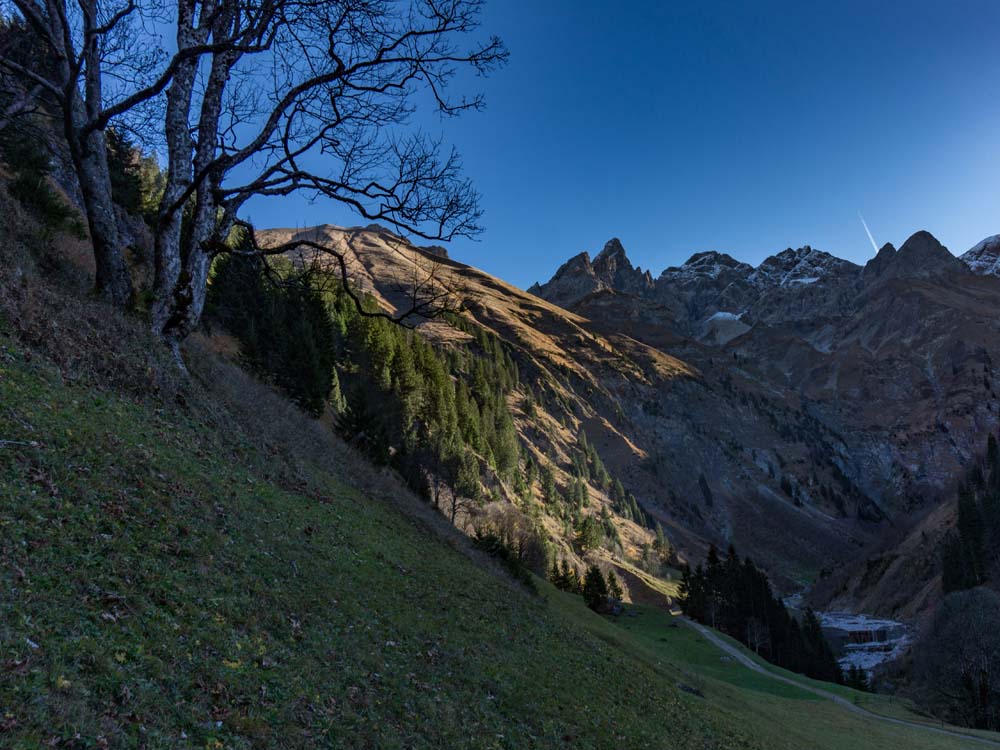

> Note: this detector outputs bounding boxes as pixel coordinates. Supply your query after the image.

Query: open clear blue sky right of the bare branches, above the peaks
[240,0,1000,287]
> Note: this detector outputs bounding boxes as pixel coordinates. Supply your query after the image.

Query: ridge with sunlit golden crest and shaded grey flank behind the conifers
[259,226,892,578]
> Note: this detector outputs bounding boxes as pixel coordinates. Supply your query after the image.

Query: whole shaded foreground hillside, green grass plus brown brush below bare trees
[0,201,984,750]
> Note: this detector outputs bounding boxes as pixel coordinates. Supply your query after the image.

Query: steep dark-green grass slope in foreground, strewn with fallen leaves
[0,339,759,748]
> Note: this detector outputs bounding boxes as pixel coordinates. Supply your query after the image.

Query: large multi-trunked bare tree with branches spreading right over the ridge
[153,0,506,360]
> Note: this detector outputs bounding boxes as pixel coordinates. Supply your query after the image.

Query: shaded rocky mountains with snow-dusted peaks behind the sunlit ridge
[539,231,1000,528]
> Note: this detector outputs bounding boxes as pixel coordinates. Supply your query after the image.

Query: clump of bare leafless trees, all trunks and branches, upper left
[0,0,507,351]
